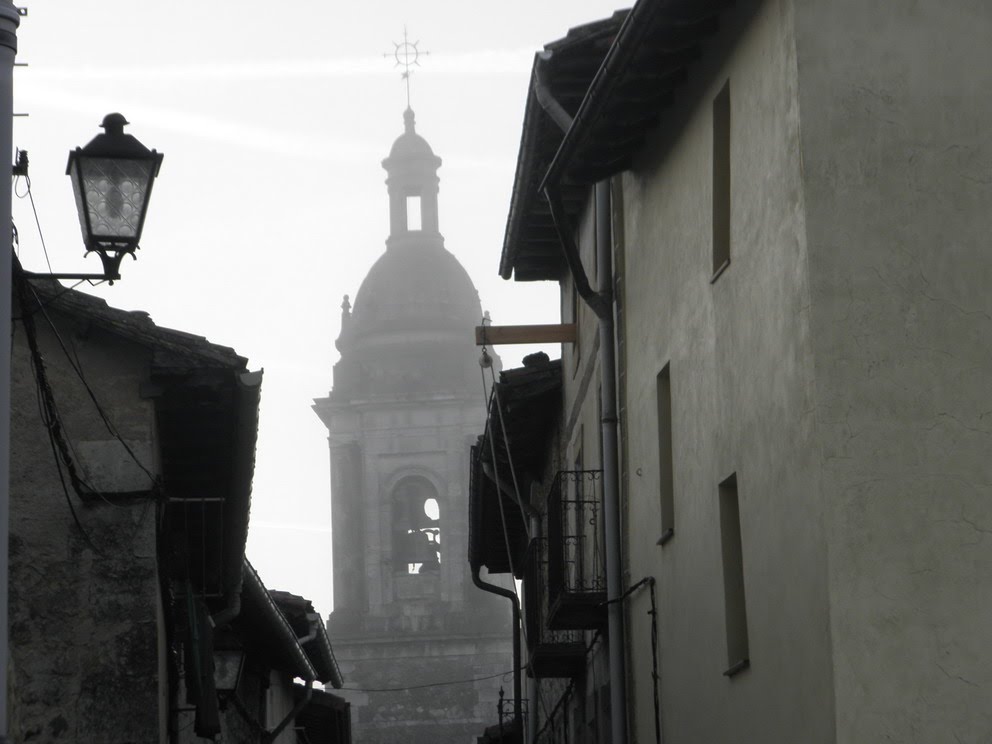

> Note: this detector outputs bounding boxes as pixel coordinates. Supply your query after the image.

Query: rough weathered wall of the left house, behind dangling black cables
[10,310,164,744]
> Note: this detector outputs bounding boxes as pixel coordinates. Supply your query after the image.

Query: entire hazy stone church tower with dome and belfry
[314,108,512,744]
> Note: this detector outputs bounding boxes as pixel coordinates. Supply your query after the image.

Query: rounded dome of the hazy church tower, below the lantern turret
[348,245,482,339]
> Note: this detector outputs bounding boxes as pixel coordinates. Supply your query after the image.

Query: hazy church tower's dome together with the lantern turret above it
[333,108,482,398]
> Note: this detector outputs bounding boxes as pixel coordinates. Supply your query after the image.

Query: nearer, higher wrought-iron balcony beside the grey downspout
[547,470,606,630]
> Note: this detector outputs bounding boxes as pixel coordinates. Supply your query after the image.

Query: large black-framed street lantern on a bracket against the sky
[61,114,162,284]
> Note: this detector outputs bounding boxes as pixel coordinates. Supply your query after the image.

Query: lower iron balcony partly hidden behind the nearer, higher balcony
[524,538,586,679]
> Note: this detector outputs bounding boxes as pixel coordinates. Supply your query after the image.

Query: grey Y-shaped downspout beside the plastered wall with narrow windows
[534,58,627,744]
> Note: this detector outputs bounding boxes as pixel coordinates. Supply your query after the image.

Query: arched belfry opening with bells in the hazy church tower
[392,476,441,574]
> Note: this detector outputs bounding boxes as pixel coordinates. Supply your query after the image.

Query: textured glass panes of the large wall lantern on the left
[72,156,154,241]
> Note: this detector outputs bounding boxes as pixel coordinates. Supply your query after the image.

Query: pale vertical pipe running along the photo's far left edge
[0,7,20,744]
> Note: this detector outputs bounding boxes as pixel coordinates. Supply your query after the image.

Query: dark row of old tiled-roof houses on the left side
[8,264,349,744]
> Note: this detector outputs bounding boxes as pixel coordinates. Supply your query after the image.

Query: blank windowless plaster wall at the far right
[795,0,992,742]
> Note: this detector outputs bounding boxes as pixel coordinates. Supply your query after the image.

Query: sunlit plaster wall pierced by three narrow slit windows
[622,0,833,744]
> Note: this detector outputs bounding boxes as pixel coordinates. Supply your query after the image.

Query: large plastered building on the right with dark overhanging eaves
[476,0,992,744]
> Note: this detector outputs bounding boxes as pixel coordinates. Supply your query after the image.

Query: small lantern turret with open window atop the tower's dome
[382,108,443,248]
